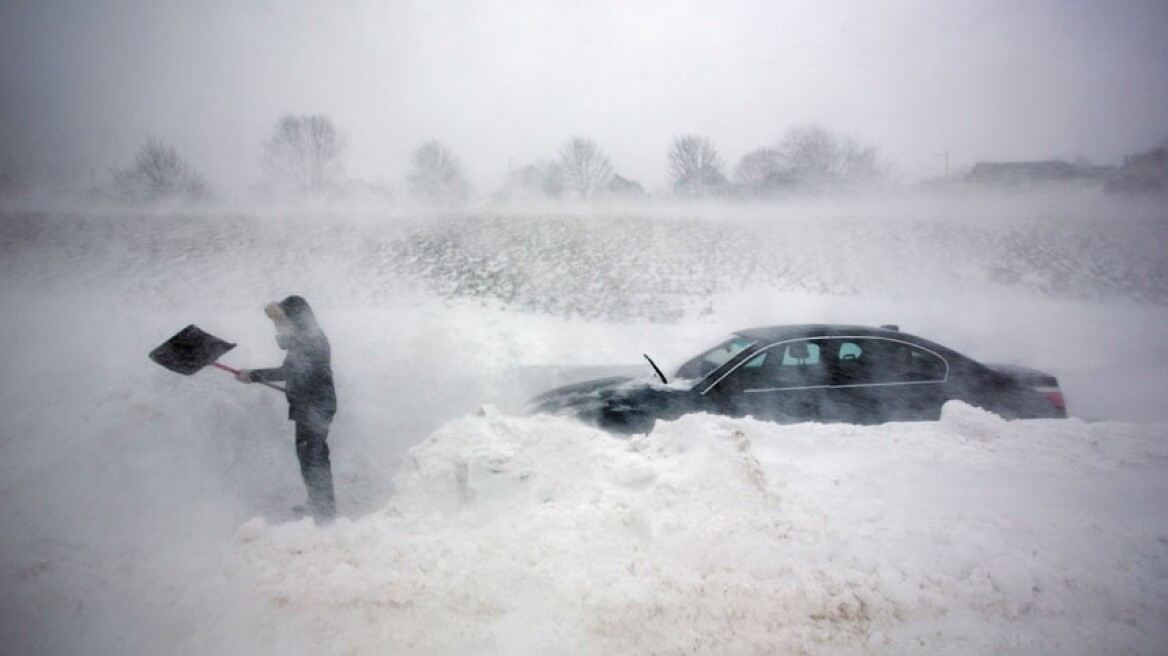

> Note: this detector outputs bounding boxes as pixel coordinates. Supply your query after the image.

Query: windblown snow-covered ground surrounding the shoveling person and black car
[0,196,1168,655]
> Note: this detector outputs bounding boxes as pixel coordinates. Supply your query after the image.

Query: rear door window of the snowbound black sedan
[836,339,948,385]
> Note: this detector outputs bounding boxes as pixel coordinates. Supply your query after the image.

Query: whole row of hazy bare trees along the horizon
[110,114,890,207]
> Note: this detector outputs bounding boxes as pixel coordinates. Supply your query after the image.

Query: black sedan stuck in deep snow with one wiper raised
[531,324,1066,433]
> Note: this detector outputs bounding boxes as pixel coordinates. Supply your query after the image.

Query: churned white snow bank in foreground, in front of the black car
[234,404,1168,654]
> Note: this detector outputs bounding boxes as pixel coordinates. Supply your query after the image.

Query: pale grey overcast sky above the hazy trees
[0,0,1168,193]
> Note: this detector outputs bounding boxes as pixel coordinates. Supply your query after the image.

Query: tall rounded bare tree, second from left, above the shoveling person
[263,114,345,196]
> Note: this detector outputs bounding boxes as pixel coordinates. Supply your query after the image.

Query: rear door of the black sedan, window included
[827,337,948,424]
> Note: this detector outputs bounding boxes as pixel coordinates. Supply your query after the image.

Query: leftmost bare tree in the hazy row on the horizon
[113,137,210,203]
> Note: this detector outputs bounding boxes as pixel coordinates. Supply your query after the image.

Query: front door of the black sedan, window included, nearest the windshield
[707,340,832,423]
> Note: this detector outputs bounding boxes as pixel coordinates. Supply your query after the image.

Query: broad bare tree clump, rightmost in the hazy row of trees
[778,126,888,187]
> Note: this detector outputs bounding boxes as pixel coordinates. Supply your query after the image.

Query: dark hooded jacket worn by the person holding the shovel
[251,296,336,421]
